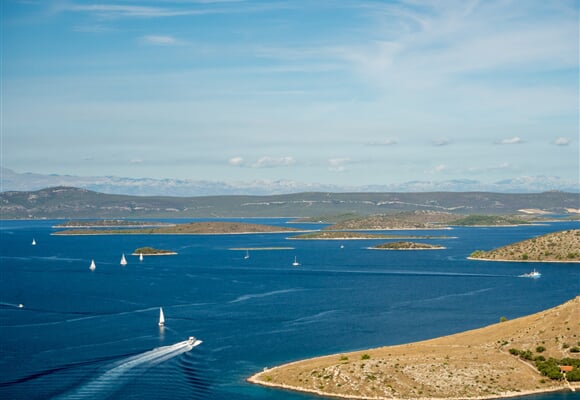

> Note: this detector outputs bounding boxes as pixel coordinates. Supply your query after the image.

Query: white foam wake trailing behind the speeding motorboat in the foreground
[59,340,202,399]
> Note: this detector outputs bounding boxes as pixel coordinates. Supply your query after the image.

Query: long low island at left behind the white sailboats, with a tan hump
[53,222,298,235]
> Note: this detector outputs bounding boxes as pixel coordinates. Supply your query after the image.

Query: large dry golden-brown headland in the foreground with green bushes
[248,297,580,399]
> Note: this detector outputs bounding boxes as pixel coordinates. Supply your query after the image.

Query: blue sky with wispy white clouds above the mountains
[0,0,580,191]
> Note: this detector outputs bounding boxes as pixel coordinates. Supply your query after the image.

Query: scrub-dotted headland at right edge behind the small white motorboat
[468,229,580,263]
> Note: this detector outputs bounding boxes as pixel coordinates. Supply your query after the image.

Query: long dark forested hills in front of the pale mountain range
[0,187,580,219]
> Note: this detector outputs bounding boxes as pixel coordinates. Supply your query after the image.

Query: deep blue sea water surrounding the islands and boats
[0,219,580,400]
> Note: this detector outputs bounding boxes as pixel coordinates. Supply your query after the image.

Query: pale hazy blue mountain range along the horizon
[0,168,580,196]
